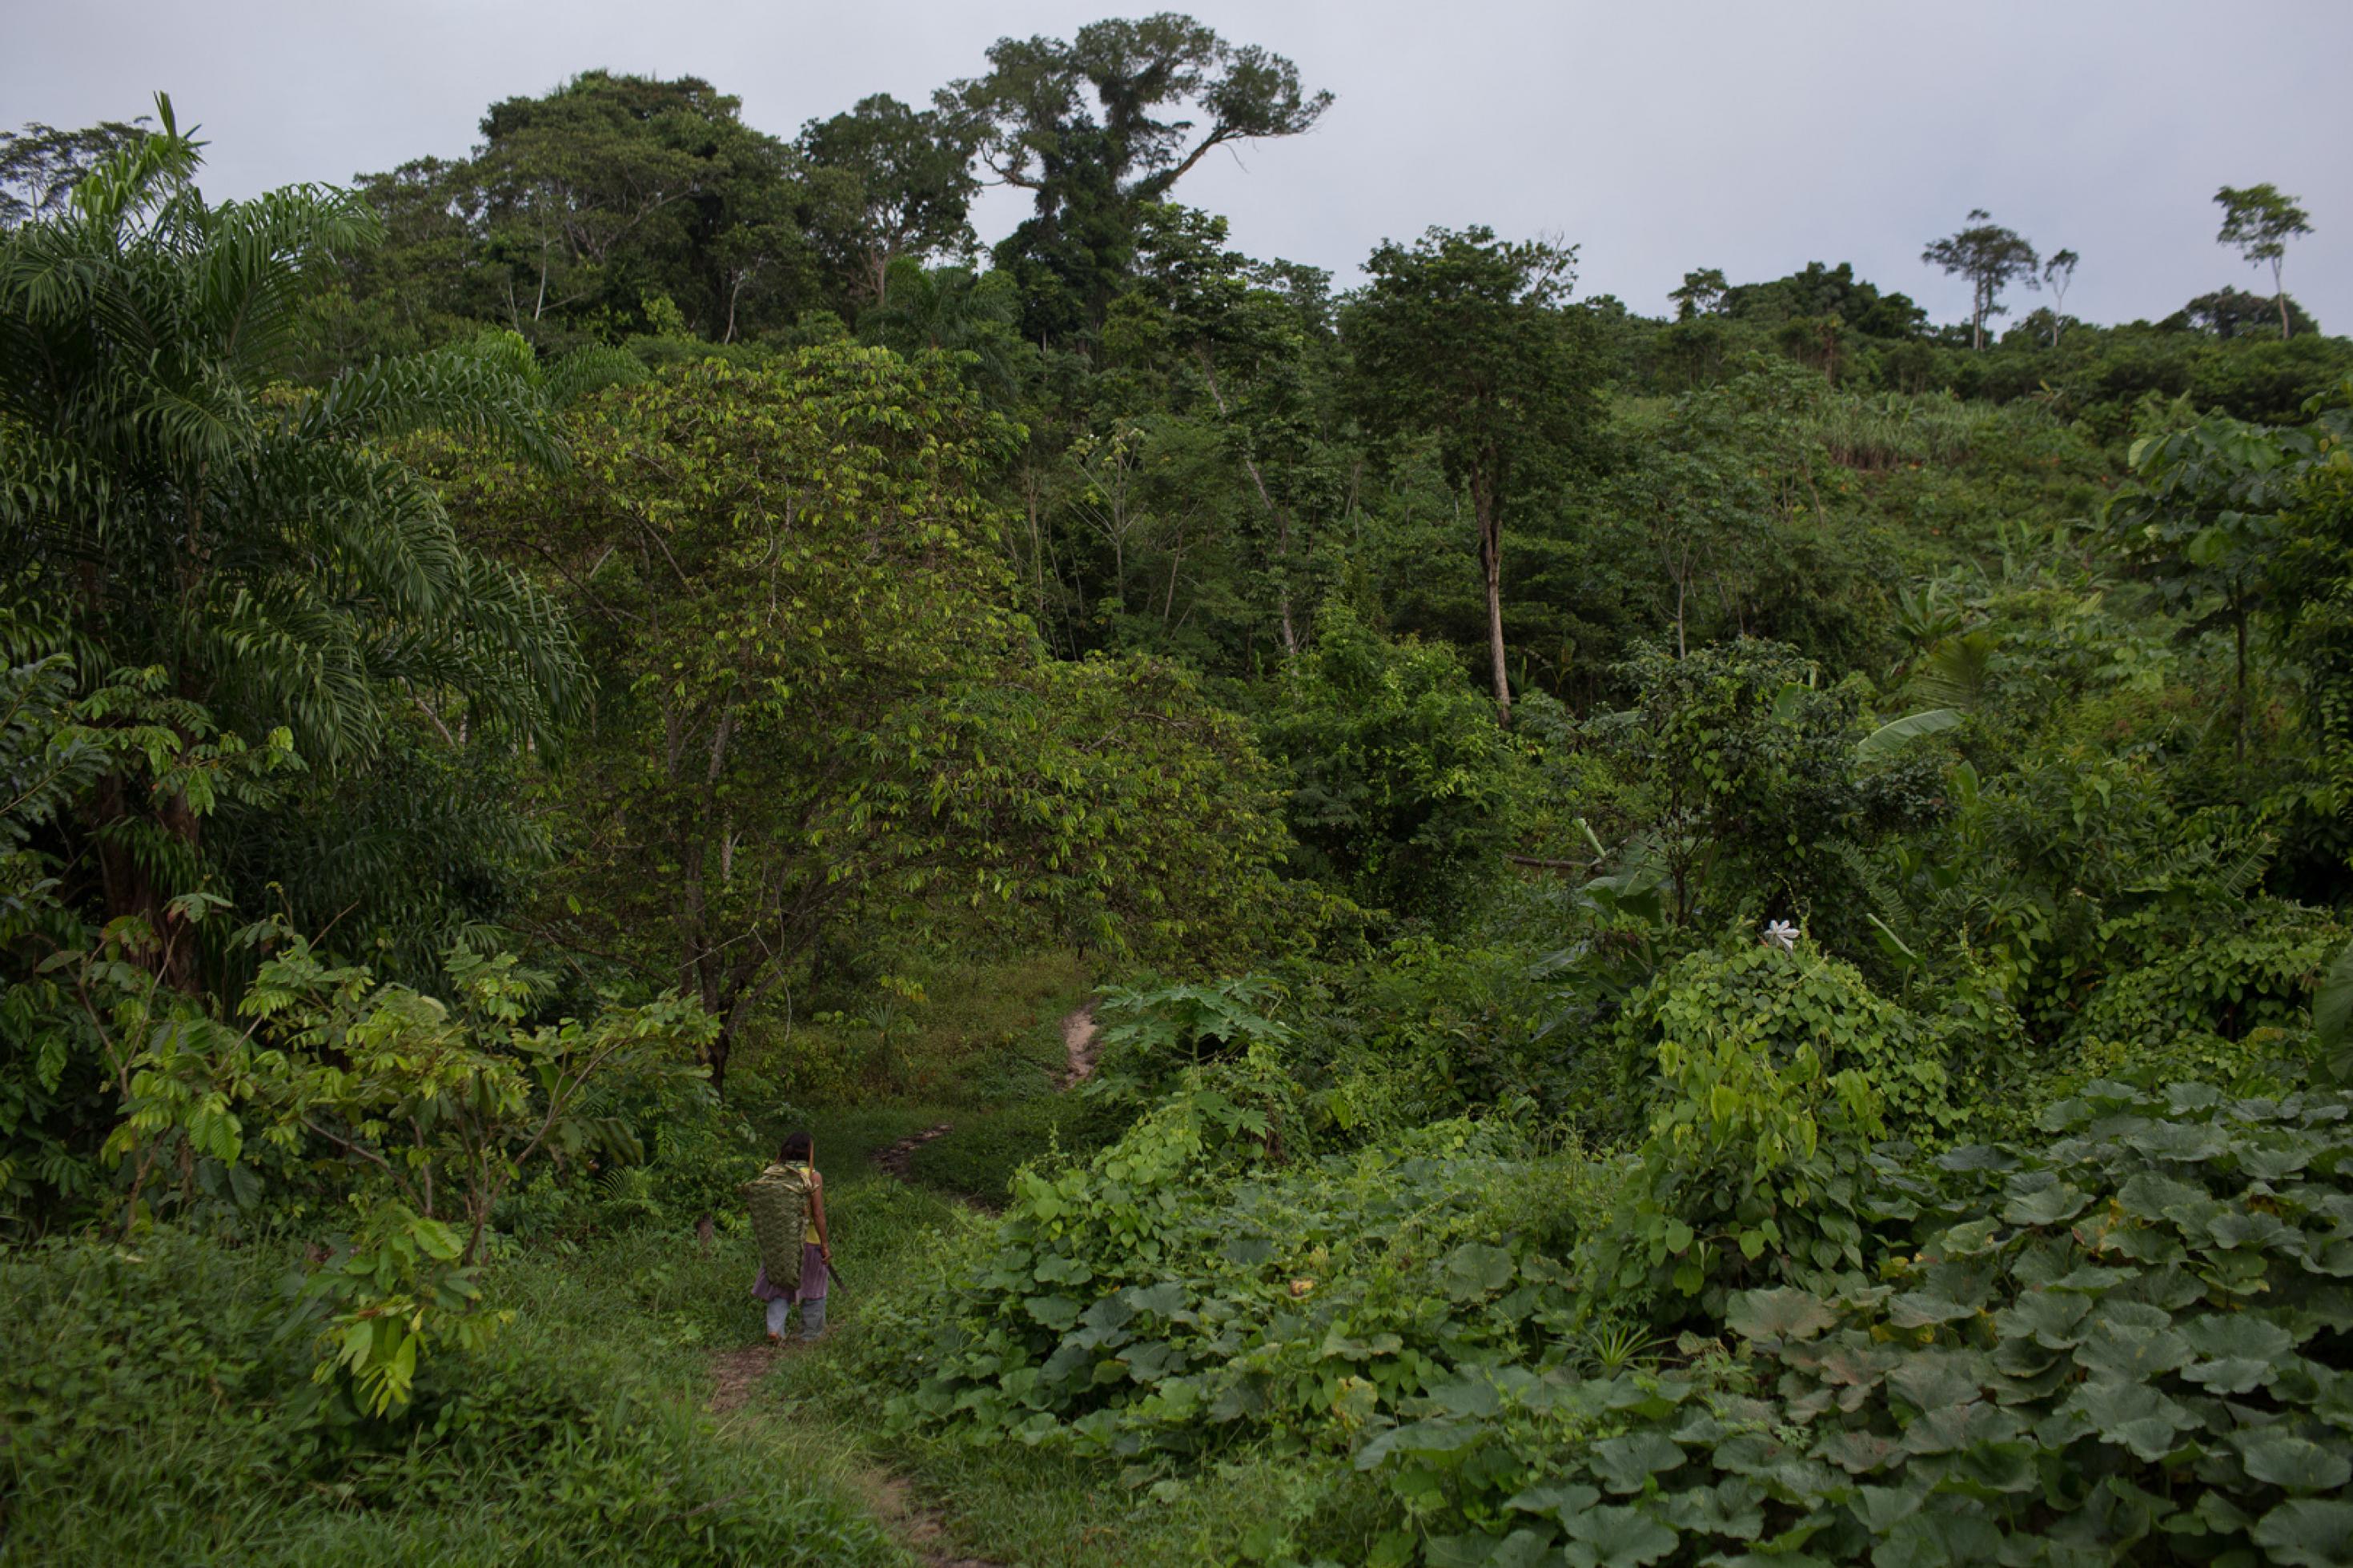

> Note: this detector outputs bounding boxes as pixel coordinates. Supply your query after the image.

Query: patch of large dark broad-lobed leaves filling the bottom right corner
[1358,1081,2353,1568]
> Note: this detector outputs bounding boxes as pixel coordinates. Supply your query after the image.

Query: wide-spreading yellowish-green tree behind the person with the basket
[464,346,1275,1079]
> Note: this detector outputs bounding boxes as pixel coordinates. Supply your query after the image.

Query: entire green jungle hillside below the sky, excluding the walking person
[0,17,2353,1568]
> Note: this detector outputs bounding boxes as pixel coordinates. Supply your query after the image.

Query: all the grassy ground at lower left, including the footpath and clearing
[0,954,1223,1568]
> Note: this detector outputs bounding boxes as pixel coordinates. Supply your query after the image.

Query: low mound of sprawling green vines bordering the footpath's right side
[875,1096,1600,1455]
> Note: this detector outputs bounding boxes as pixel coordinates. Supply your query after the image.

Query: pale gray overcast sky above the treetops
[0,0,2353,331]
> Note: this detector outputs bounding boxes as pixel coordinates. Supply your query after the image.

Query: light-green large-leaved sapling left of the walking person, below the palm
[91,928,709,1415]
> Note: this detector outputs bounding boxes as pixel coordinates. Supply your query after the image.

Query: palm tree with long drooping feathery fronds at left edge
[0,96,586,988]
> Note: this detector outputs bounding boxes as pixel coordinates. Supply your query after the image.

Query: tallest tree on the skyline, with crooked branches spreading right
[937,12,1331,339]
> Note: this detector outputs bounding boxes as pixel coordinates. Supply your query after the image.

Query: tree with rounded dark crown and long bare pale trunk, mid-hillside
[1341,226,1600,724]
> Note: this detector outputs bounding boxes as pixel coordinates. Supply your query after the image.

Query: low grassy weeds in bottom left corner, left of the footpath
[0,1229,899,1566]
